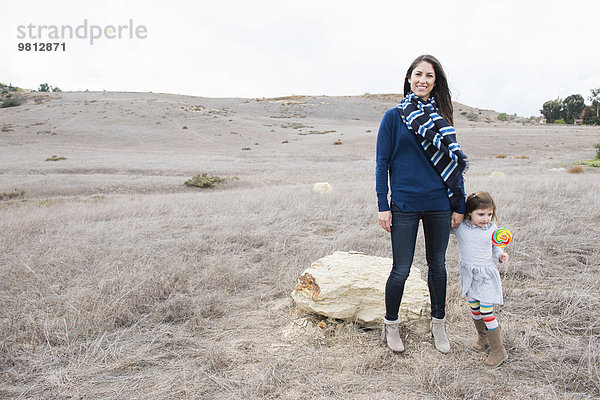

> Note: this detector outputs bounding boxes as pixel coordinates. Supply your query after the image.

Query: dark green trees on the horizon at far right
[540,88,600,125]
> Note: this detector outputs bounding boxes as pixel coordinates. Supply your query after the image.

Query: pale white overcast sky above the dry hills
[0,0,600,116]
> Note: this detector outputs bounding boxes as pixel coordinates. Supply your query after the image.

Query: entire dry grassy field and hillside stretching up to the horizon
[0,93,600,399]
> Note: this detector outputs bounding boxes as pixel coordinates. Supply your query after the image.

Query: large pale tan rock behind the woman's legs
[292,251,430,327]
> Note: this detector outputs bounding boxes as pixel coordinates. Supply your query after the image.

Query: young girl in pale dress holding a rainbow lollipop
[452,192,508,367]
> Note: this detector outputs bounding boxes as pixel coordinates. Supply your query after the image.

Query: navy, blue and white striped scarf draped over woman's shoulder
[398,92,467,210]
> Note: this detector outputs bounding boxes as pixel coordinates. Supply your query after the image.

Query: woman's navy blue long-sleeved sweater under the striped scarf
[375,107,465,214]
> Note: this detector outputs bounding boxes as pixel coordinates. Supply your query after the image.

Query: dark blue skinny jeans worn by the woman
[385,203,452,321]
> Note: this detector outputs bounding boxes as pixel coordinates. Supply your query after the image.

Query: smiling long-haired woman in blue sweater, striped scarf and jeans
[376,55,466,353]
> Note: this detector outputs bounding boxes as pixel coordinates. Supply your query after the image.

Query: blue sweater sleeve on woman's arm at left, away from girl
[375,113,393,211]
